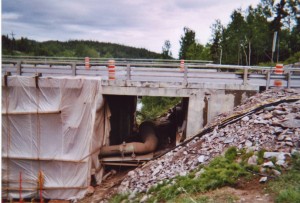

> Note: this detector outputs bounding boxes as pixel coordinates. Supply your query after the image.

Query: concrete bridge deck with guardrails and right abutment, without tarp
[2,57,300,137]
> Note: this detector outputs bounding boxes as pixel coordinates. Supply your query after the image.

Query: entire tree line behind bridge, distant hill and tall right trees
[2,0,300,65]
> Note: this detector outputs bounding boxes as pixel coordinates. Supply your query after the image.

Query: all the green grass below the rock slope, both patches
[110,147,300,203]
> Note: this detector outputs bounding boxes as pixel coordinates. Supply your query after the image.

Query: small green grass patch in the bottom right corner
[268,154,300,203]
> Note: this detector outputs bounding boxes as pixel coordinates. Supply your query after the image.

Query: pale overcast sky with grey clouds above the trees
[2,0,259,57]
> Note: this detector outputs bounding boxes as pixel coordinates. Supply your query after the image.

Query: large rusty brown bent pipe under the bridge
[100,122,158,157]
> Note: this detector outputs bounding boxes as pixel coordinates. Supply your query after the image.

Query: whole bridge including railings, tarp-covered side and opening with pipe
[2,57,300,199]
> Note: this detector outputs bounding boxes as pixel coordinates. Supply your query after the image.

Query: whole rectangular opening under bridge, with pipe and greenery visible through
[99,95,188,169]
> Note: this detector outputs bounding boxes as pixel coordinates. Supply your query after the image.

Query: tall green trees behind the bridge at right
[163,0,300,65]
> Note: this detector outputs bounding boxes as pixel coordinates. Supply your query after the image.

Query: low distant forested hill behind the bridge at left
[2,35,161,58]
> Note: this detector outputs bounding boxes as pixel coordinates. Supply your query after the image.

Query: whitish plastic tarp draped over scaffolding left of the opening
[2,76,110,199]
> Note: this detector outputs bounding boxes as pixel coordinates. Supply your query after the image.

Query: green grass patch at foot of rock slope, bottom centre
[148,147,251,202]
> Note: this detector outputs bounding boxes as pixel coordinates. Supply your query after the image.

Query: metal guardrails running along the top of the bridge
[2,57,300,88]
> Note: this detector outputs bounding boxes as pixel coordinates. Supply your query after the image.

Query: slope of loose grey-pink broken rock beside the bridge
[119,90,300,192]
